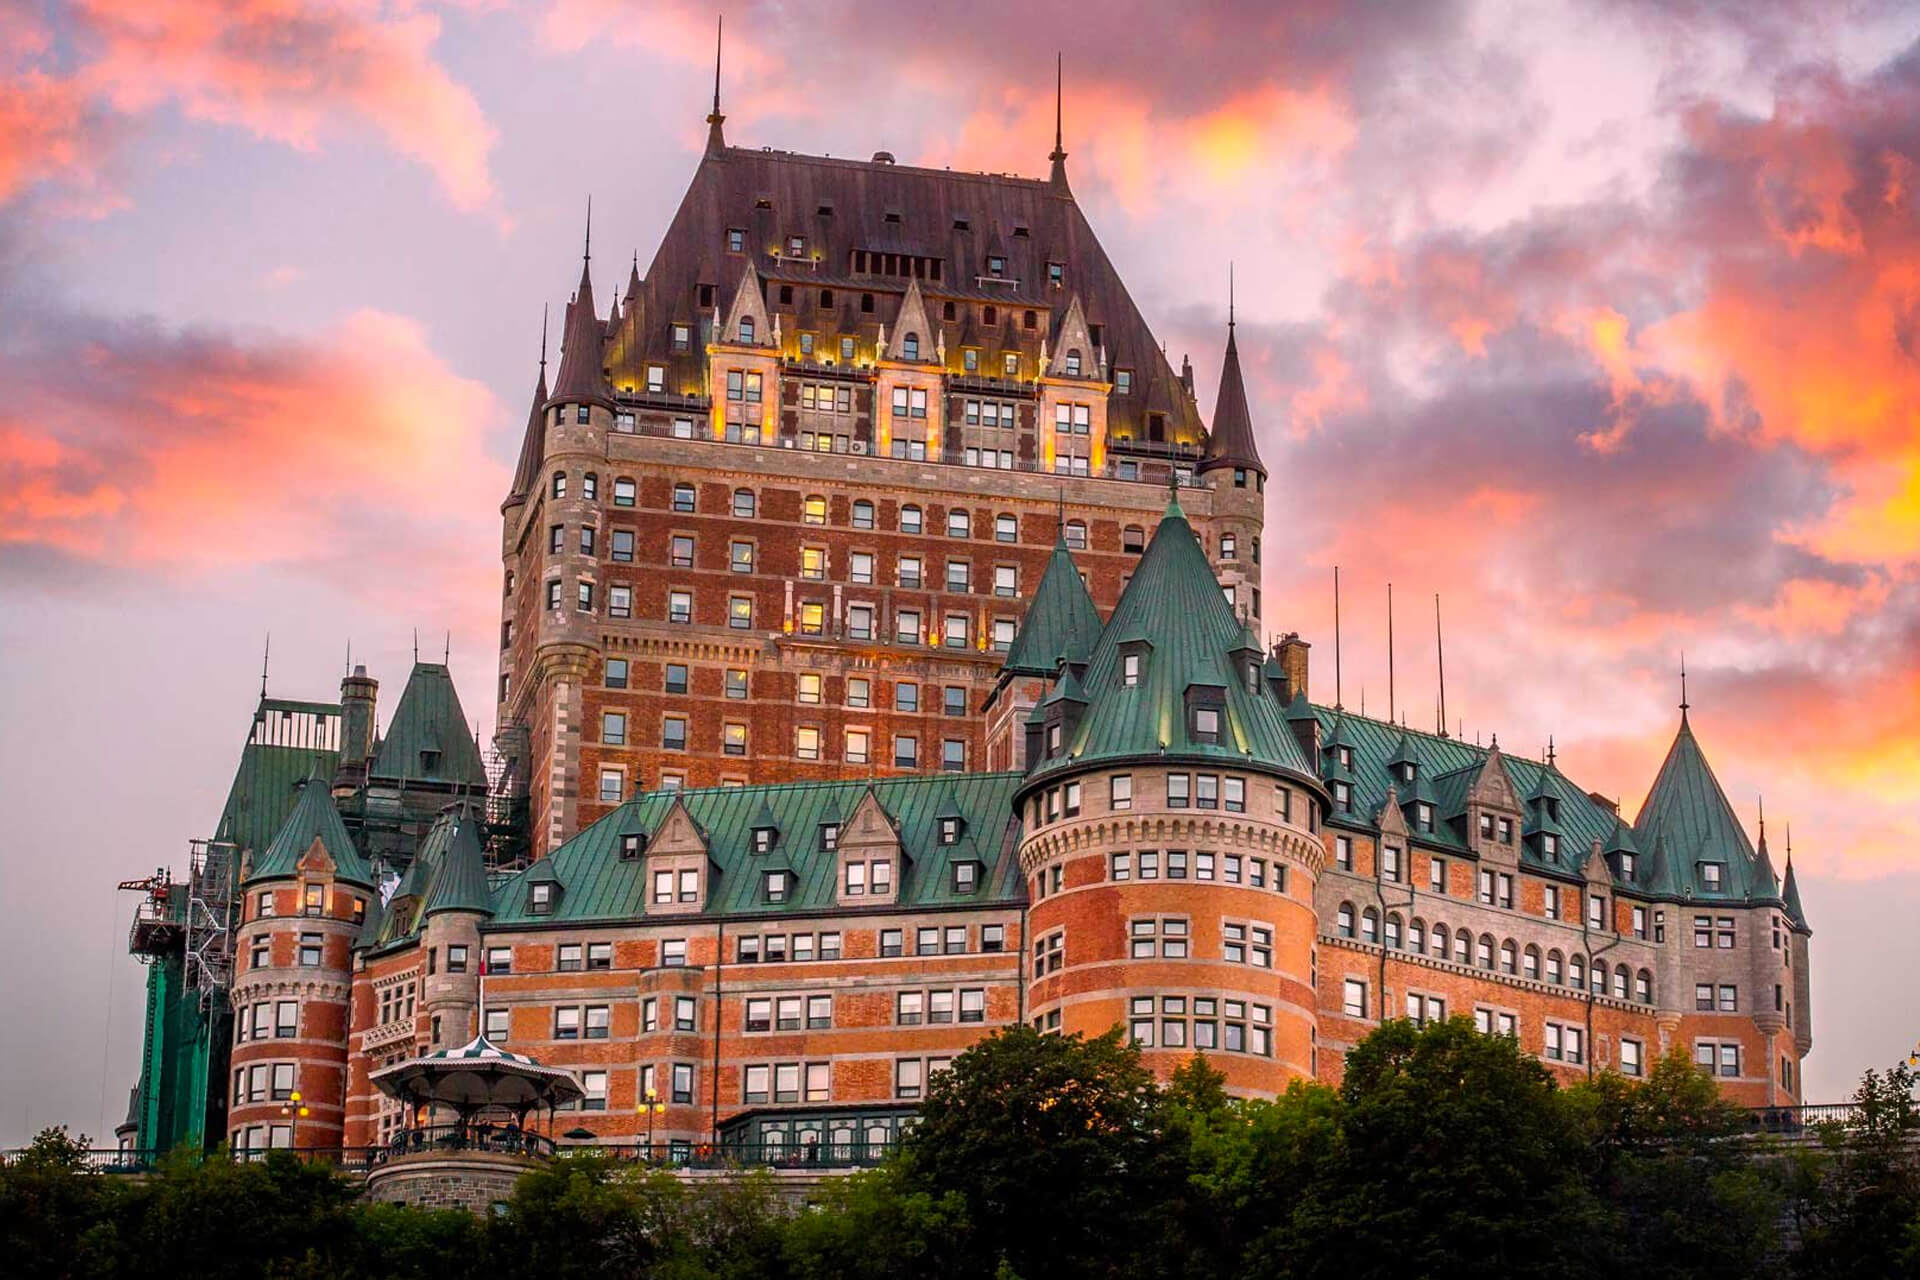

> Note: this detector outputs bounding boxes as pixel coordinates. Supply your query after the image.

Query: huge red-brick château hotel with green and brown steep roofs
[129,100,1812,1150]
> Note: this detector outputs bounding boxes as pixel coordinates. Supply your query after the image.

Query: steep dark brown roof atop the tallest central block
[607,141,1206,445]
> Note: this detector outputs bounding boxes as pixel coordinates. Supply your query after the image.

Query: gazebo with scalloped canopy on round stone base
[367,1034,584,1213]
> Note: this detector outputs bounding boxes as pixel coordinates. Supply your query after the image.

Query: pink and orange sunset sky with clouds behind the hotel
[0,0,1920,1146]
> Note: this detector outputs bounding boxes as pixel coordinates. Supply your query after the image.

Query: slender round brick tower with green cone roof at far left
[227,777,374,1148]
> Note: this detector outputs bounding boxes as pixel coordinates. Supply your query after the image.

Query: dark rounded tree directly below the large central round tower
[899,1027,1164,1276]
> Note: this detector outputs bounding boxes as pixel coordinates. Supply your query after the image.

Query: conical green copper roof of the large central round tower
[1033,503,1313,777]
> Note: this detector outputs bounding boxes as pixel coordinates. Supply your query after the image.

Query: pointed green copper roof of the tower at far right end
[1634,710,1780,902]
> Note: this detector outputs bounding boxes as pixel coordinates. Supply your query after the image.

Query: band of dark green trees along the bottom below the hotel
[0,1043,1920,1280]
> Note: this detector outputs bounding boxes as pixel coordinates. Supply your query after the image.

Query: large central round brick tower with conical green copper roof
[1016,505,1325,1096]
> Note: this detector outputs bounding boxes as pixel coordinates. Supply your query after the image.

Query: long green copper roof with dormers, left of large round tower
[488,773,1025,929]
